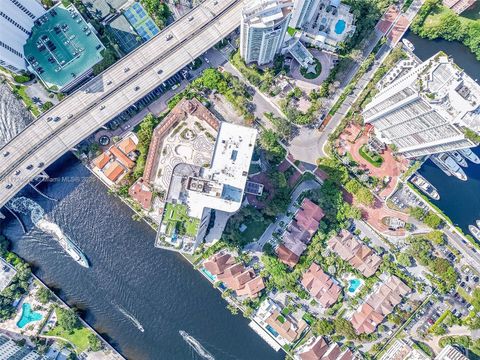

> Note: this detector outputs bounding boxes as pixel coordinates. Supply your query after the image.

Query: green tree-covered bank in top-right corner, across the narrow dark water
[411,0,480,60]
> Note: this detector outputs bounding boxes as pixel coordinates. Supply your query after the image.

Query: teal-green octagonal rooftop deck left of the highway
[24,5,104,89]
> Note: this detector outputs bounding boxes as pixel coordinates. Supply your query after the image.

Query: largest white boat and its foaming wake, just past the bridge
[8,196,89,268]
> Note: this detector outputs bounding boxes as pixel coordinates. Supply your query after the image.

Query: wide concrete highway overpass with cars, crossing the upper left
[0,0,242,208]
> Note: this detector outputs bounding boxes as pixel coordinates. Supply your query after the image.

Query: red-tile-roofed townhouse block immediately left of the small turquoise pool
[302,263,342,309]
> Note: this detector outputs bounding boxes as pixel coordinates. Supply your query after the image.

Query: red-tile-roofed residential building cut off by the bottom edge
[295,336,356,360]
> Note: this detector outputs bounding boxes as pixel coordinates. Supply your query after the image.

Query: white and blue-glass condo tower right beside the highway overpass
[240,0,292,65]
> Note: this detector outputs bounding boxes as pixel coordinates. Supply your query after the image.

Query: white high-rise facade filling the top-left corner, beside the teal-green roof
[0,0,45,72]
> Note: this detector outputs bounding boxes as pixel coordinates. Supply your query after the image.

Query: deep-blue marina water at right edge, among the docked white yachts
[419,147,480,234]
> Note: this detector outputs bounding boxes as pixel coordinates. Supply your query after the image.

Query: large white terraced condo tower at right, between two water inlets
[363,53,480,157]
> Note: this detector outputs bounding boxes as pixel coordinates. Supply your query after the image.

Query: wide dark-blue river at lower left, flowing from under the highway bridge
[1,154,284,360]
